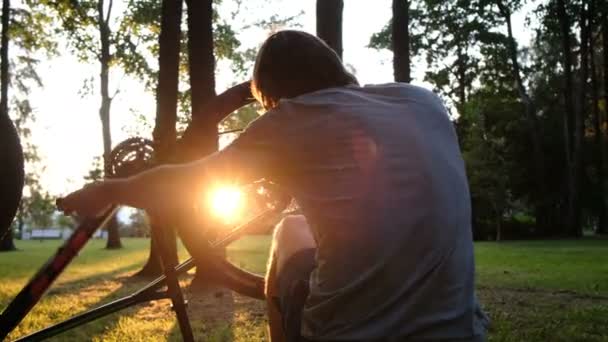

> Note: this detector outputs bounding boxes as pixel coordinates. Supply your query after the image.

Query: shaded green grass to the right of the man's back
[475,239,608,341]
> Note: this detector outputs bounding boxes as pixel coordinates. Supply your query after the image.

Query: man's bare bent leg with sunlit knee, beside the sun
[266,215,316,342]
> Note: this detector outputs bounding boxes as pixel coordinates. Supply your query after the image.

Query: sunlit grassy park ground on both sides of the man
[0,236,608,341]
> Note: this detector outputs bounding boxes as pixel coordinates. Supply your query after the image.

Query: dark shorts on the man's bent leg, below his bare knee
[274,248,316,342]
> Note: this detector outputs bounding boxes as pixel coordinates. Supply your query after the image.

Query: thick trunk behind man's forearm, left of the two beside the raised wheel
[137,0,182,276]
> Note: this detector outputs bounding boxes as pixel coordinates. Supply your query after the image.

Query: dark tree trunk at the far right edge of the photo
[589,1,607,234]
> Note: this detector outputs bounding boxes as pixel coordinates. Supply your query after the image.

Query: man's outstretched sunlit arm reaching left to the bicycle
[57,103,290,216]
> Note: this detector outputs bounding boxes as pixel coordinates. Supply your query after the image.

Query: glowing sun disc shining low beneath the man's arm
[207,185,245,223]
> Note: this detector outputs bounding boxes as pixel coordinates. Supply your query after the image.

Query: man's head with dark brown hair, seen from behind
[251,30,357,110]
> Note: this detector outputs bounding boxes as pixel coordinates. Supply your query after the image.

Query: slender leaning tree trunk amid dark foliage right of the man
[496,0,550,235]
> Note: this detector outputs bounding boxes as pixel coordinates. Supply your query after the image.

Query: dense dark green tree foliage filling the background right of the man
[369,0,608,238]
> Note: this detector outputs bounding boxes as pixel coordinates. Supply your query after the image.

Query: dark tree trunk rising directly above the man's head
[317,0,344,58]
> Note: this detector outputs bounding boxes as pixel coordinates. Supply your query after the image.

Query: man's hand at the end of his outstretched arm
[57,181,117,217]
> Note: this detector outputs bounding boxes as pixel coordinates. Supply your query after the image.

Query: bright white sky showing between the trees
[25,0,530,196]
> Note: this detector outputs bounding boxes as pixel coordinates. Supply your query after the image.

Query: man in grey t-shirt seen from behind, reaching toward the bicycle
[61,31,487,341]
